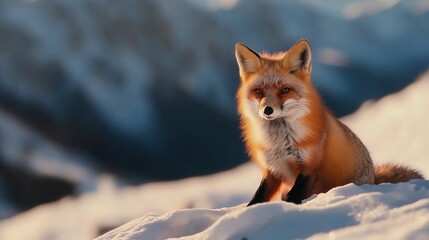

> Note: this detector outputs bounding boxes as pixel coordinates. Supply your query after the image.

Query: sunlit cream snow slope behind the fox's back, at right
[343,72,429,172]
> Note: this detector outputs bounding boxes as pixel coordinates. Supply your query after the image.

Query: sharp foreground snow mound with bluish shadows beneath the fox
[97,180,429,240]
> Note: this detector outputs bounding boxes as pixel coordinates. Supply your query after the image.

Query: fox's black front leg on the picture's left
[247,173,281,206]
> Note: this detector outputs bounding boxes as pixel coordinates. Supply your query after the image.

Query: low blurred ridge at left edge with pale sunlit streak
[0,110,101,219]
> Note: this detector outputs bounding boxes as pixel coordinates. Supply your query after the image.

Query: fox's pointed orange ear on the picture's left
[235,43,261,77]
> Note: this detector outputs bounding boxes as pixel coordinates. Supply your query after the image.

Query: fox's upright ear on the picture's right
[283,39,311,73]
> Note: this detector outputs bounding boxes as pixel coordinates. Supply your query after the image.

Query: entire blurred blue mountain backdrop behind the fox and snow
[0,0,429,225]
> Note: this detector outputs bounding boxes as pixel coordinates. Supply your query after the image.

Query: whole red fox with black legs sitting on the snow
[235,39,423,206]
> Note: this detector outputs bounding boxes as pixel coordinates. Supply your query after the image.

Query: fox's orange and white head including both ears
[235,39,315,121]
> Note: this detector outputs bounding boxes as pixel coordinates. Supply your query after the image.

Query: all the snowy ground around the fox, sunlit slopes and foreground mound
[0,72,429,240]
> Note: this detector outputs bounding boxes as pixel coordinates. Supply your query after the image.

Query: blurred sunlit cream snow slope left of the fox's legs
[0,164,260,240]
